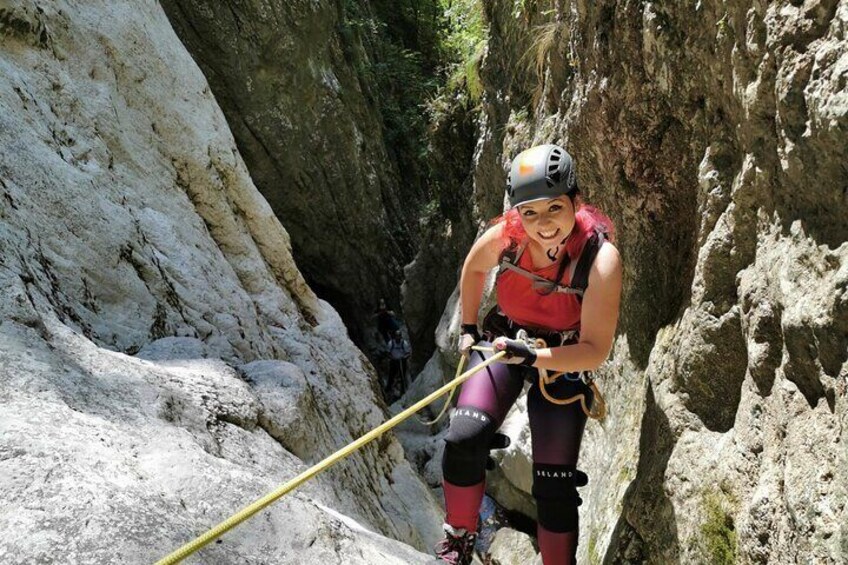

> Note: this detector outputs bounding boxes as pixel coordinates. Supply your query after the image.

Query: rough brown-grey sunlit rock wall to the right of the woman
[420,0,848,563]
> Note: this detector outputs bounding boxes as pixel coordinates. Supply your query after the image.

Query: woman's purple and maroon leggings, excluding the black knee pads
[444,344,591,565]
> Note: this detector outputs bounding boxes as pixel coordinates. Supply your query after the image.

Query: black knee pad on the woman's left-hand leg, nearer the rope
[442,406,496,487]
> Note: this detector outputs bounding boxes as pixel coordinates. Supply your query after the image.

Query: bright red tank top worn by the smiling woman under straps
[495,250,580,332]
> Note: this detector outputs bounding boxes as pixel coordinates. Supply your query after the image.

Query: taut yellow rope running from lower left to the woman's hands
[156,352,506,565]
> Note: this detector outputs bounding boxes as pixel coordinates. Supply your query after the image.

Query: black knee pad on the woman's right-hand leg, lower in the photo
[533,463,589,533]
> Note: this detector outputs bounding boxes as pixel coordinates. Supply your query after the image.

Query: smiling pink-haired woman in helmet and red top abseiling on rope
[436,145,622,565]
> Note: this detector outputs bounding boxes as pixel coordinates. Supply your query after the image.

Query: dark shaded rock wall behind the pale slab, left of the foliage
[157,0,422,343]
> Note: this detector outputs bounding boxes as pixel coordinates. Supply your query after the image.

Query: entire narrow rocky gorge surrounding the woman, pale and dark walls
[0,0,848,565]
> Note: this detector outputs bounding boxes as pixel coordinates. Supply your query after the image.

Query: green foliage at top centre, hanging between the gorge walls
[340,0,487,203]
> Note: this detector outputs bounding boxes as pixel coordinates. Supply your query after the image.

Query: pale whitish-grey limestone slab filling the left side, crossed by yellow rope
[0,0,441,564]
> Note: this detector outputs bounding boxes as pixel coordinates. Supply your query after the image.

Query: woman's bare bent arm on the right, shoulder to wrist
[533,242,622,373]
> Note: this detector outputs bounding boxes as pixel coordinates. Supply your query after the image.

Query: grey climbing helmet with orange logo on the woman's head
[506,145,577,207]
